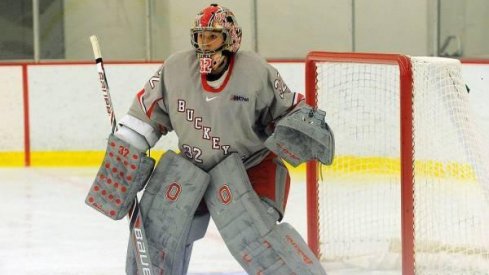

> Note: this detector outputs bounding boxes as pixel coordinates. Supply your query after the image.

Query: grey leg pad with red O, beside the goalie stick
[126,151,210,274]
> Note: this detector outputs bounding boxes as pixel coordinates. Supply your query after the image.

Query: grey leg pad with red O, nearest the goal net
[205,154,326,275]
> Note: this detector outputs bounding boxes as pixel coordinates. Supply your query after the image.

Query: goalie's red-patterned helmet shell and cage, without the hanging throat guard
[190,4,241,57]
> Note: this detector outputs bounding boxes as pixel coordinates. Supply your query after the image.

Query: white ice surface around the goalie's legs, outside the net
[0,168,306,275]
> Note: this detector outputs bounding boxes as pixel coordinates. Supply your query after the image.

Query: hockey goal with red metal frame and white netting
[306,52,489,274]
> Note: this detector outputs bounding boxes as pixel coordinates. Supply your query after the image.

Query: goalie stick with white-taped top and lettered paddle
[90,35,155,275]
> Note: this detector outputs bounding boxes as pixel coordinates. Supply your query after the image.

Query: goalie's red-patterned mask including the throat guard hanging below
[190,4,241,73]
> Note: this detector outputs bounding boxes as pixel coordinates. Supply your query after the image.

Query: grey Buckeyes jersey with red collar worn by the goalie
[129,50,302,170]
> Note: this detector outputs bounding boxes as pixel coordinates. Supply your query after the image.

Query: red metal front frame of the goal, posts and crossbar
[305,52,414,274]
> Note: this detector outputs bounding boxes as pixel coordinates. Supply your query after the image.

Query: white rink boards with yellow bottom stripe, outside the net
[0,62,489,167]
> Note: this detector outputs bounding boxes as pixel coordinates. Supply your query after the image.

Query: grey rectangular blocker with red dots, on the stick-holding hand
[85,134,155,220]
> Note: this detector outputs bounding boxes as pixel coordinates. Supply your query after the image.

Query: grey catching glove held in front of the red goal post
[265,102,335,167]
